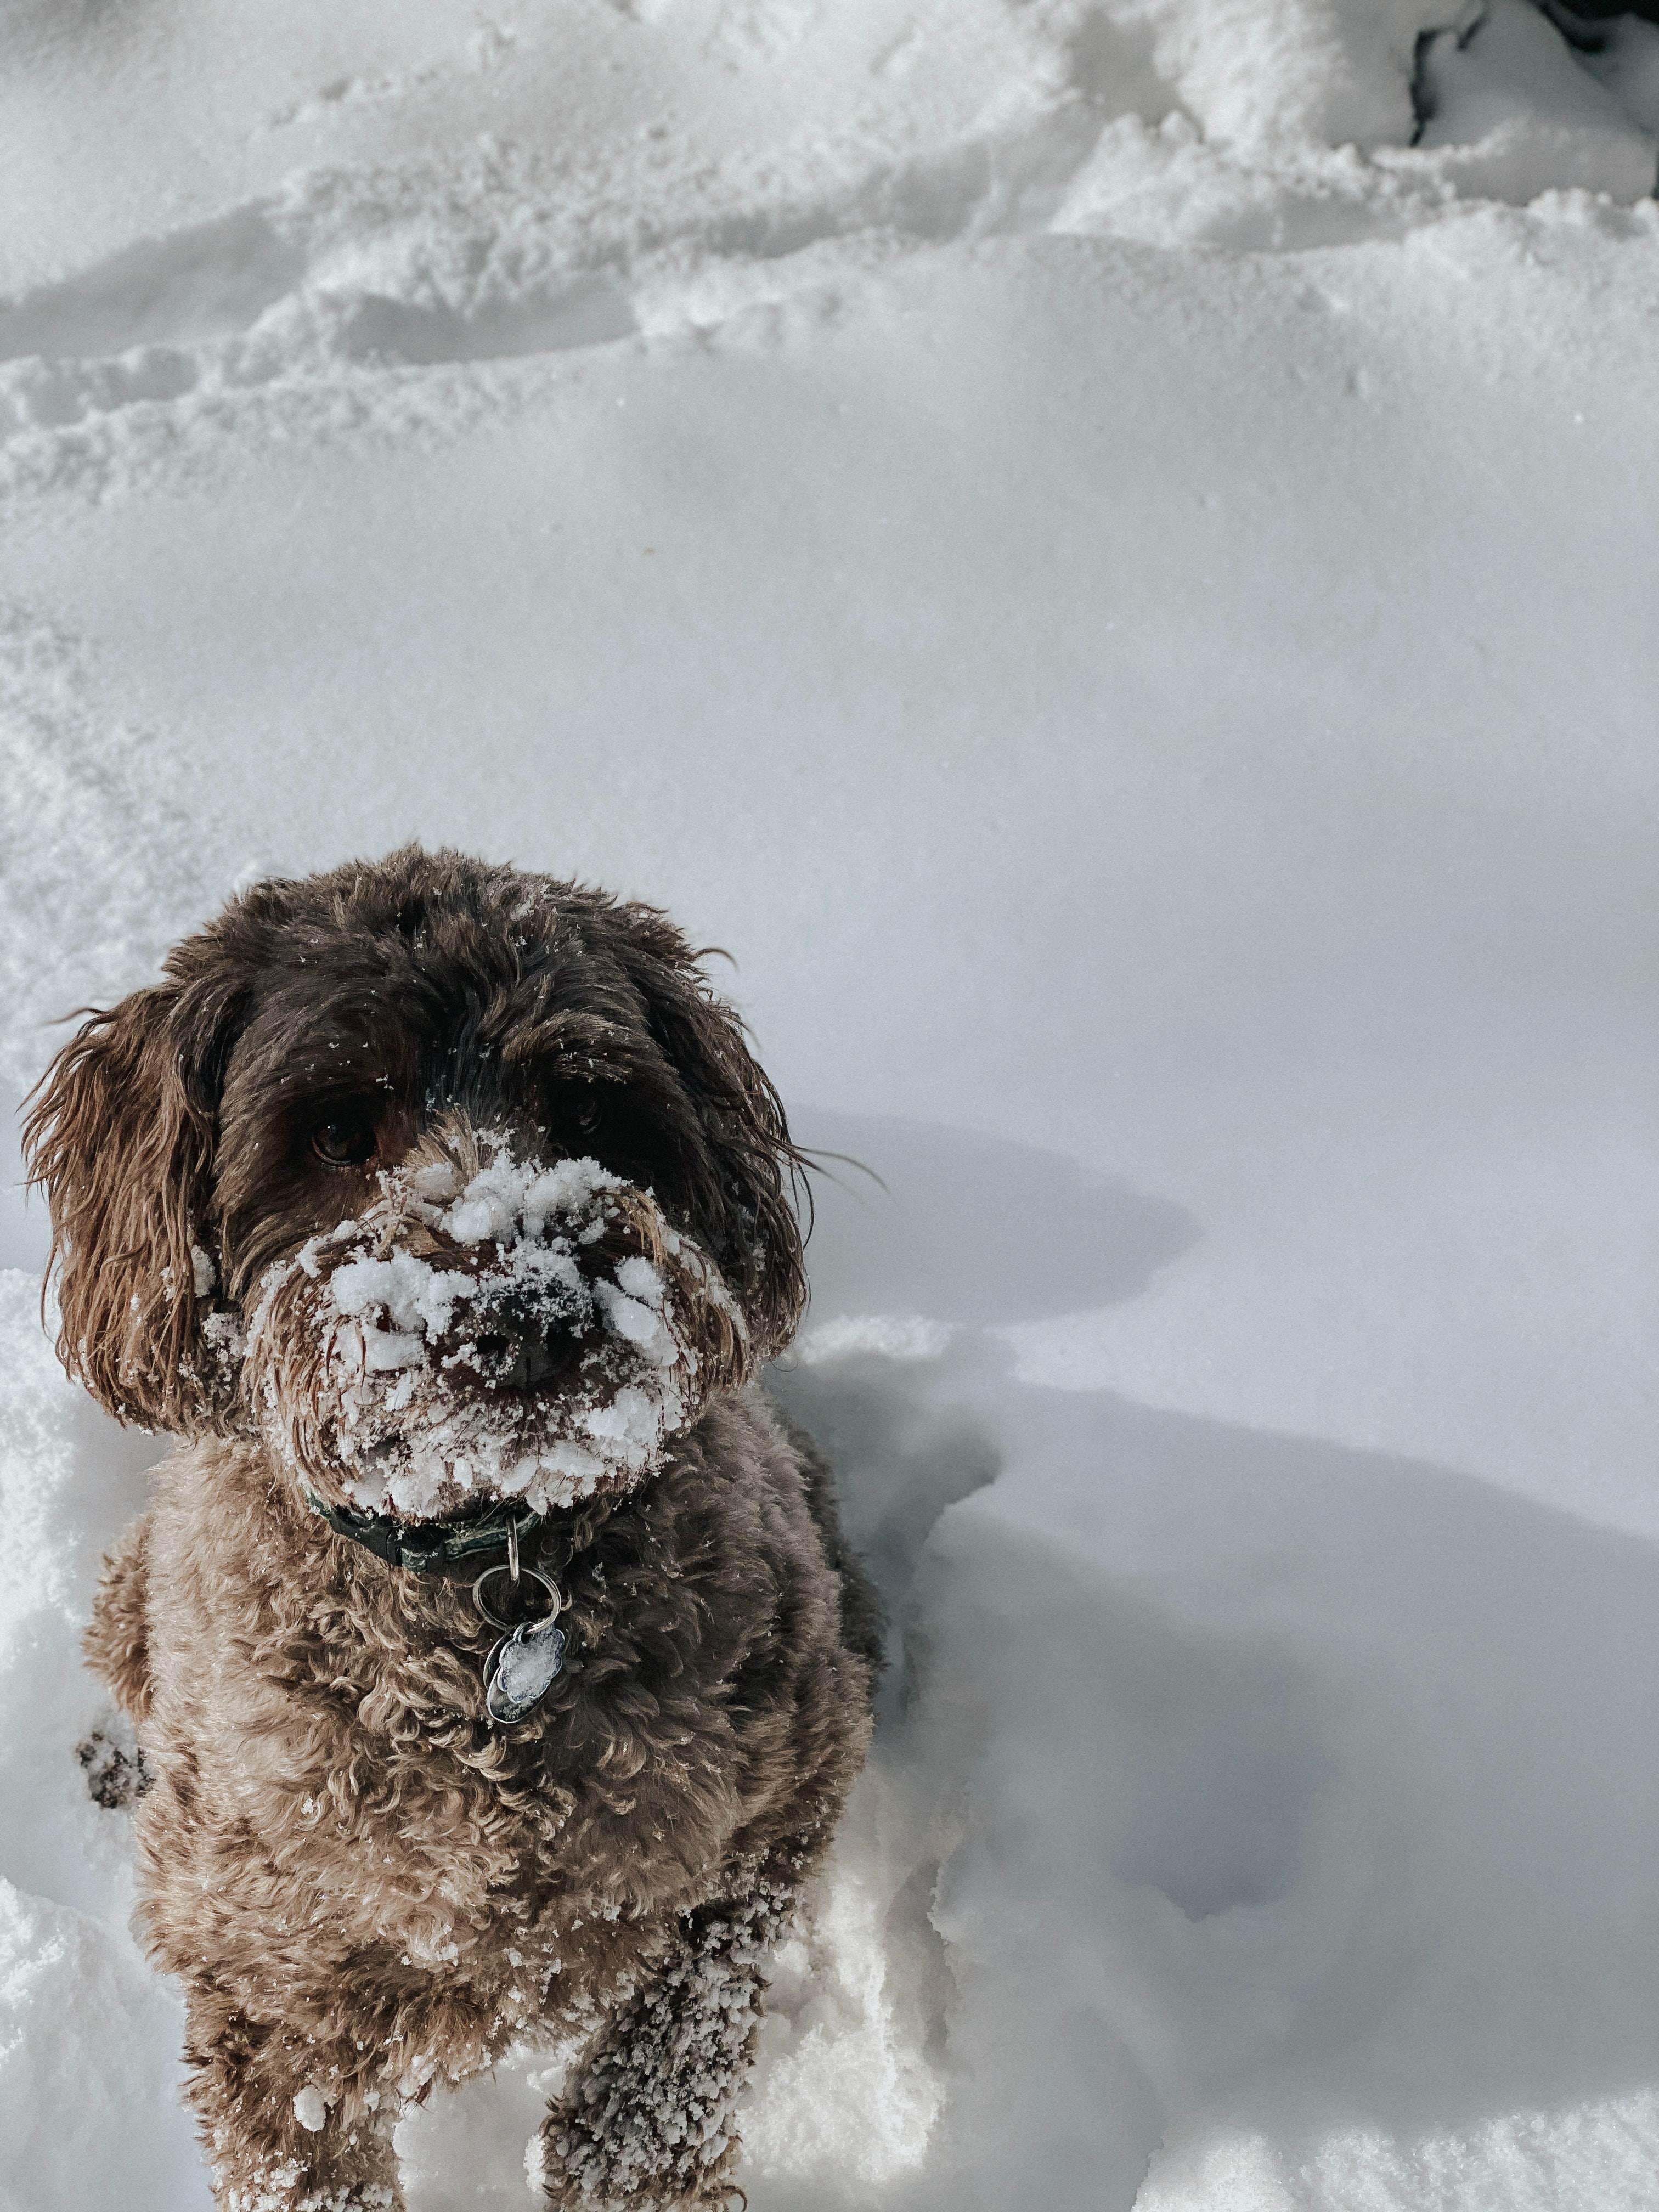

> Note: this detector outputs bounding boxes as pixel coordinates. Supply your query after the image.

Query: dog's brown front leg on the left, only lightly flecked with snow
[186,1991,403,2212]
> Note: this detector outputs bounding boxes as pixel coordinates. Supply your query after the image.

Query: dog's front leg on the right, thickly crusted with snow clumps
[540,1856,794,2212]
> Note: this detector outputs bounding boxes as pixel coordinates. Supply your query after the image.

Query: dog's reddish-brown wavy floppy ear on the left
[24,982,240,1434]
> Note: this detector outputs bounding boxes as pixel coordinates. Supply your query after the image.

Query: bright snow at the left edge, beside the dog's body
[0,1269,208,2212]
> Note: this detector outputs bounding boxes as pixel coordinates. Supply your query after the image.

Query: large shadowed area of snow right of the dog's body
[781,1325,1659,2212]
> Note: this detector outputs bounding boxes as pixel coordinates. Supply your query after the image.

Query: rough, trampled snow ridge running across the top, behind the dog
[0,0,1659,484]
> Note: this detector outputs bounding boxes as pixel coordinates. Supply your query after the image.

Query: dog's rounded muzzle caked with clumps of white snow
[244,1126,750,1520]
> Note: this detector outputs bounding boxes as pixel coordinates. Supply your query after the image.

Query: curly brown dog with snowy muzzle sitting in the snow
[26,847,881,2212]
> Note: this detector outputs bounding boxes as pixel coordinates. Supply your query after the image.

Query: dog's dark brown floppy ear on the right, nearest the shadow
[617,905,808,1358]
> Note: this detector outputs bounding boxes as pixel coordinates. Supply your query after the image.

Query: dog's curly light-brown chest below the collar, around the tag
[150,1415,814,1957]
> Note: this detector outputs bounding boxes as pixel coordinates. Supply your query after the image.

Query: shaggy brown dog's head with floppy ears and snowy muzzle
[26,847,805,1517]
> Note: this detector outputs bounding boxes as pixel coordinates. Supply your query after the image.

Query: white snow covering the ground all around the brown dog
[0,0,1659,2212]
